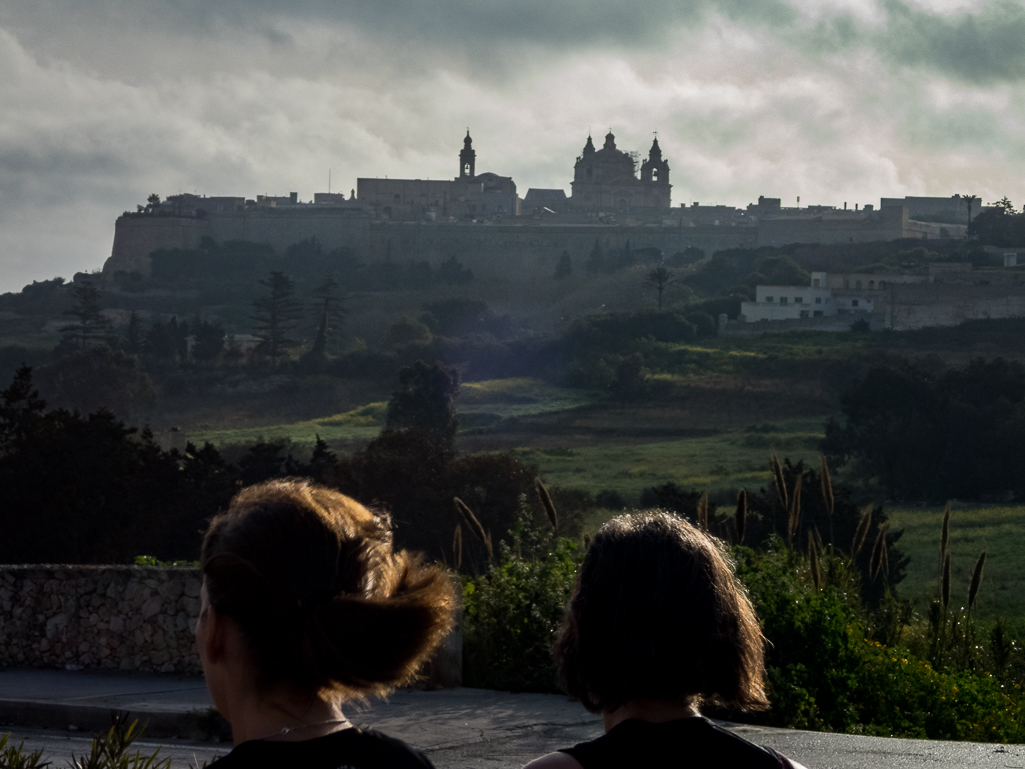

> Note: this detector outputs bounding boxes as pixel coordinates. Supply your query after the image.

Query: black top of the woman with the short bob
[560,718,792,769]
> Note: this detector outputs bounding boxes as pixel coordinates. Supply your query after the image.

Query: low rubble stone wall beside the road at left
[0,565,201,674]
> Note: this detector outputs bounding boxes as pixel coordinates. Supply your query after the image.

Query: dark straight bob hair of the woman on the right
[552,511,769,713]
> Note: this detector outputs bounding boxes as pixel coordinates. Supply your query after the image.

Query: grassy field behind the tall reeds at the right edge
[887,504,1025,619]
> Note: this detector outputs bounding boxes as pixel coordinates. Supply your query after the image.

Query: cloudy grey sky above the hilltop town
[0,0,1025,291]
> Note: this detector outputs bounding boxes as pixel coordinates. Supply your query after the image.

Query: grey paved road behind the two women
[0,671,1025,769]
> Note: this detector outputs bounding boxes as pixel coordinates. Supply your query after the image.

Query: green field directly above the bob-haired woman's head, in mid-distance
[513,419,823,504]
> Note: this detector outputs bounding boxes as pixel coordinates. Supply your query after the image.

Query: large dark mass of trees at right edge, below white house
[823,358,1025,501]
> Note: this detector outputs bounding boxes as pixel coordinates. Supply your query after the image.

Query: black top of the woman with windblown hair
[207,727,435,769]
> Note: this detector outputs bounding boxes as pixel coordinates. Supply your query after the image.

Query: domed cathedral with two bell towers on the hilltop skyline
[570,131,671,211]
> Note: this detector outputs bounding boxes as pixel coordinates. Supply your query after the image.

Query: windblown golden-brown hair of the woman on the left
[201,479,456,696]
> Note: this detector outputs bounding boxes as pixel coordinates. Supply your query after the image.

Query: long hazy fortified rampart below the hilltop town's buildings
[104,198,951,275]
